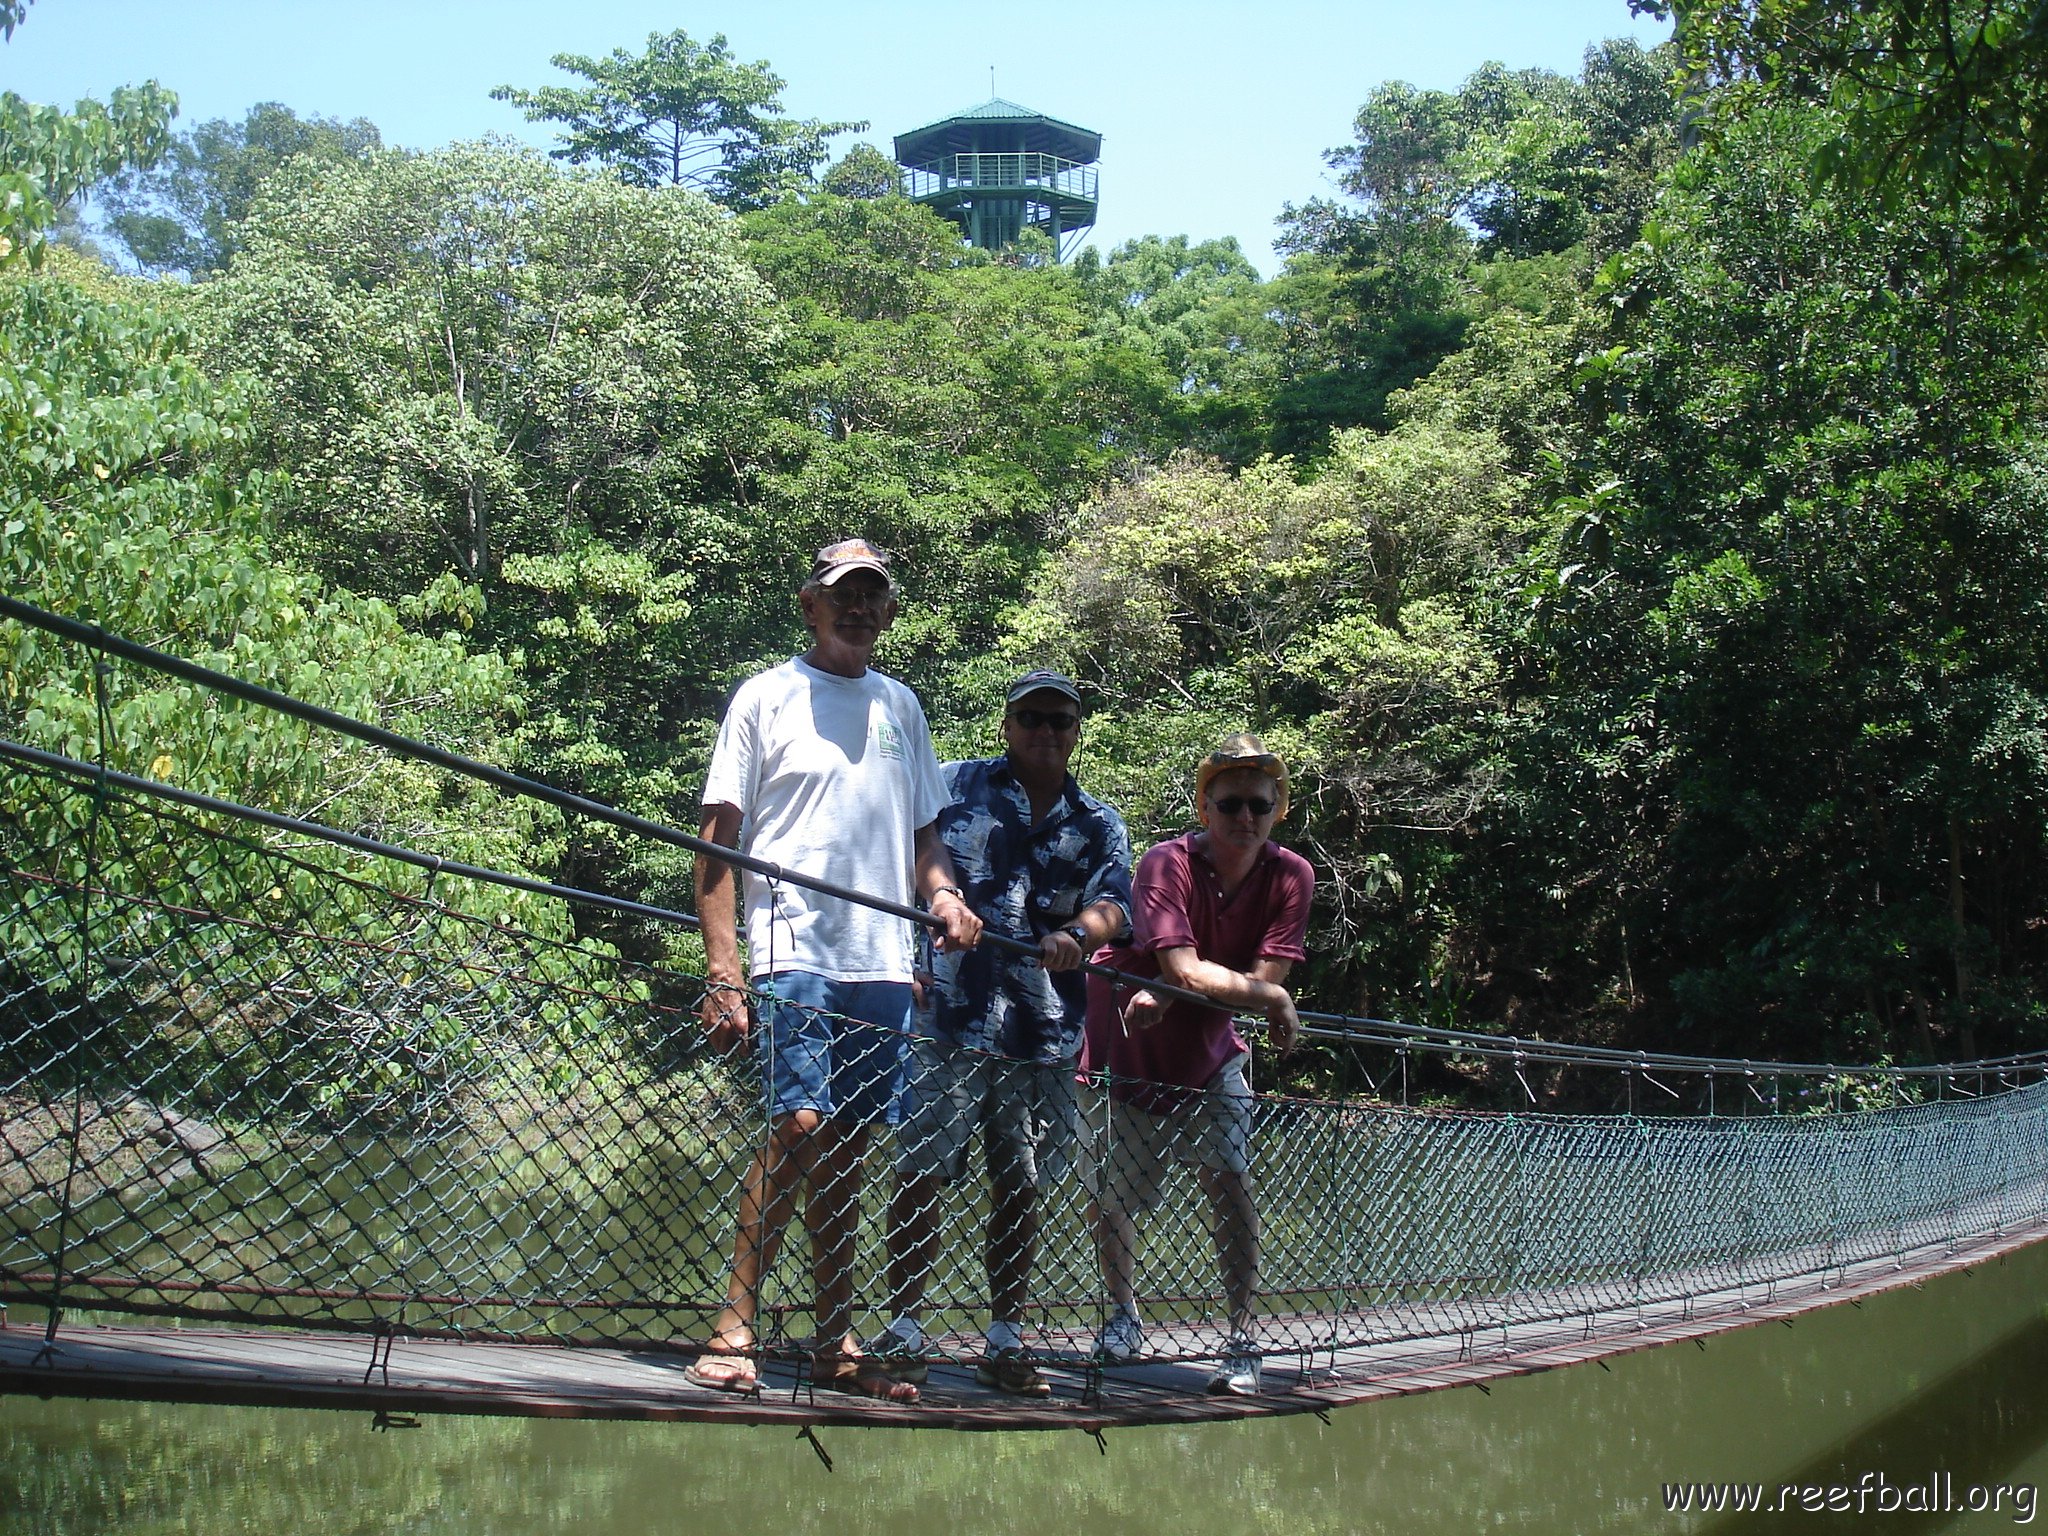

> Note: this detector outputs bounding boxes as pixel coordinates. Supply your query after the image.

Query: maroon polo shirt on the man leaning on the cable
[1081,831,1315,1112]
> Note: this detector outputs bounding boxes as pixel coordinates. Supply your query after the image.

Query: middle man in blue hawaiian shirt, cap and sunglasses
[870,672,1130,1397]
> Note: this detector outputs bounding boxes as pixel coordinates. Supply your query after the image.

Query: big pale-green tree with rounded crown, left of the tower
[193,145,774,909]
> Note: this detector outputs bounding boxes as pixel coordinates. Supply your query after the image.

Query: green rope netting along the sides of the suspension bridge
[0,741,2048,1360]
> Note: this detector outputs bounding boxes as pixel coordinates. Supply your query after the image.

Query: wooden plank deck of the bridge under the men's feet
[0,1223,2048,1432]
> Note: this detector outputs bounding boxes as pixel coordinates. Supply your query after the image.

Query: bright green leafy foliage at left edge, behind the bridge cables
[0,243,606,1118]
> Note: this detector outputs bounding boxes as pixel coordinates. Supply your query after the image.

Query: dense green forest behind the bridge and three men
[0,0,2048,1059]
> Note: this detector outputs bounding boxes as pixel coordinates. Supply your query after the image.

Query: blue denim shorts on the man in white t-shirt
[754,971,911,1124]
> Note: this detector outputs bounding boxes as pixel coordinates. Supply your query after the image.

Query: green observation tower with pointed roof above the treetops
[895,96,1102,260]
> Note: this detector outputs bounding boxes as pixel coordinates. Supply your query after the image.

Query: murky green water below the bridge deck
[12,1245,2048,1536]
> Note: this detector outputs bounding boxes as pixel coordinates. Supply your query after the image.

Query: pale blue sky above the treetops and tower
[0,0,1667,276]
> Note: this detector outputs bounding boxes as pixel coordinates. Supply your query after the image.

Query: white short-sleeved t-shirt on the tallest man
[705,657,946,981]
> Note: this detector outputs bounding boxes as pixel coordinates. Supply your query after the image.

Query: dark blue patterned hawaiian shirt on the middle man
[924,758,1130,1063]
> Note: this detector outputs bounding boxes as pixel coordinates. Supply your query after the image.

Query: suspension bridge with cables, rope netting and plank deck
[0,598,2048,1432]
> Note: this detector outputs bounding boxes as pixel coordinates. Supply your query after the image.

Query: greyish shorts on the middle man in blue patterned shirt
[897,1036,1081,1190]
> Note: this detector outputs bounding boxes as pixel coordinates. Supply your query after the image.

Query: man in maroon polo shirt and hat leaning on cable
[1085,733,1315,1397]
